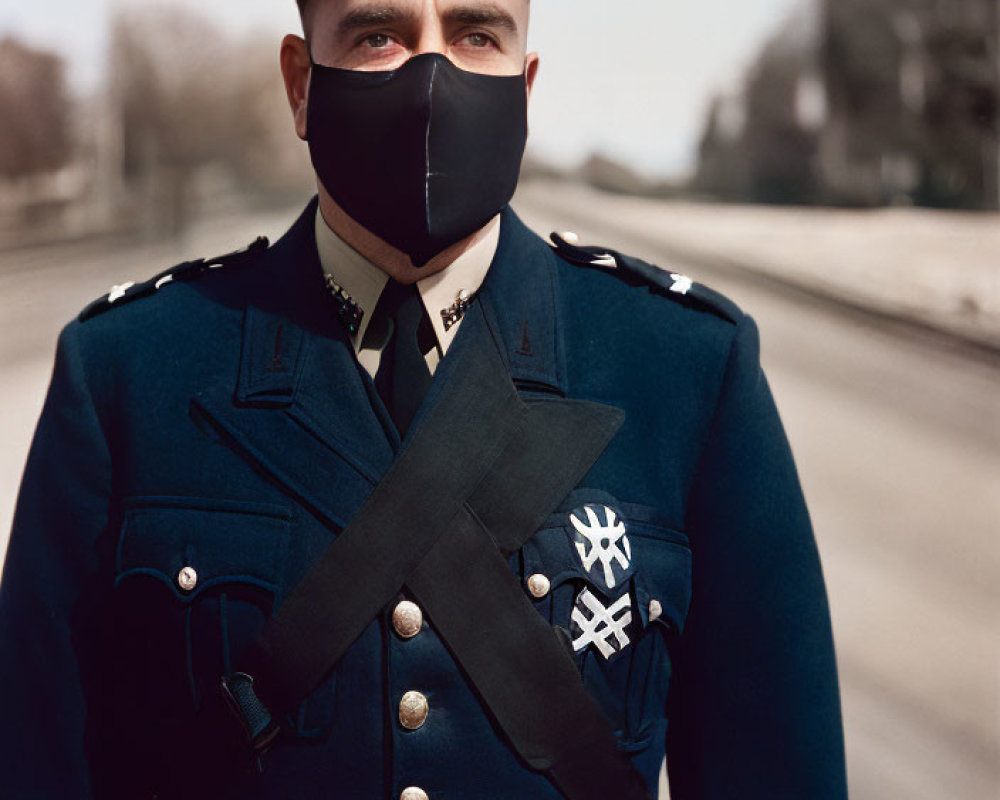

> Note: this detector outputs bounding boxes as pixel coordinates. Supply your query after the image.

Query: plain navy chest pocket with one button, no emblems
[115,497,291,715]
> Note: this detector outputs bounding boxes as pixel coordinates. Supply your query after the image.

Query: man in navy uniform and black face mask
[0,0,845,800]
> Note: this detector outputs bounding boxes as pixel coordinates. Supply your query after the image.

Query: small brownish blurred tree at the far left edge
[0,37,72,178]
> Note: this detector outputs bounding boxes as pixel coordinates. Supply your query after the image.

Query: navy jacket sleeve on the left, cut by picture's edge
[0,322,110,799]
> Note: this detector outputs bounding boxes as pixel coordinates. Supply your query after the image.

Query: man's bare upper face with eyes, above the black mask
[304,0,531,75]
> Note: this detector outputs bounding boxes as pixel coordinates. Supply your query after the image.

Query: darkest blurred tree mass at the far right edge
[822,0,1000,208]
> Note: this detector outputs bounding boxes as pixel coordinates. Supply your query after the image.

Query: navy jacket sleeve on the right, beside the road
[667,317,847,800]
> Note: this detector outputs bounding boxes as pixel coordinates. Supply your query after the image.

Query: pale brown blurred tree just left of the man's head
[110,6,309,231]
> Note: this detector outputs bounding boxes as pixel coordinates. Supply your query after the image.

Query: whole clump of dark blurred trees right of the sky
[694,0,1000,208]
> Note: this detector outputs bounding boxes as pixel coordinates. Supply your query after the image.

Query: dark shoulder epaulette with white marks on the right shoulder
[551,232,743,323]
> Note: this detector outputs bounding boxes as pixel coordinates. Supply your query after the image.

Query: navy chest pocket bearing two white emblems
[520,490,691,751]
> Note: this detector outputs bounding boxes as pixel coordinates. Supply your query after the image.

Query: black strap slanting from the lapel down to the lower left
[245,332,527,709]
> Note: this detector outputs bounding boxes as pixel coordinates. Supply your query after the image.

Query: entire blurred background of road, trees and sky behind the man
[0,0,1000,800]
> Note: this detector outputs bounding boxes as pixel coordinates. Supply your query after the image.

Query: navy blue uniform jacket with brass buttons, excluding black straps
[0,201,846,800]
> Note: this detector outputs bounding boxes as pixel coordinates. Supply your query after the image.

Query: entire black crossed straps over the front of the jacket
[207,316,648,800]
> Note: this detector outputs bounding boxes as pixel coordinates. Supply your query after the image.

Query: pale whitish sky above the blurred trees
[0,0,809,175]
